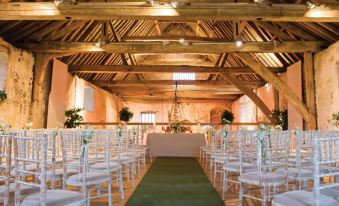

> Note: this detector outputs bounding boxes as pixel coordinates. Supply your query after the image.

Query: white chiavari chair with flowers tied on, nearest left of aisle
[60,129,112,205]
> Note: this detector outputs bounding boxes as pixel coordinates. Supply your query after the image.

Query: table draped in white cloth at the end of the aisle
[147,133,206,157]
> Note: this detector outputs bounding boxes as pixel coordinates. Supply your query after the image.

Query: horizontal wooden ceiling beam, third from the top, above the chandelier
[68,65,286,74]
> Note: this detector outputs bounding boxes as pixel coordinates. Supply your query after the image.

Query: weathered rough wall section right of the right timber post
[314,41,339,129]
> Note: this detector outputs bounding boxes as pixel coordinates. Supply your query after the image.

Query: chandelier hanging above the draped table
[168,81,185,123]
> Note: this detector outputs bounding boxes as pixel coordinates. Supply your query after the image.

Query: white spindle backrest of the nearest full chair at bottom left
[13,131,50,205]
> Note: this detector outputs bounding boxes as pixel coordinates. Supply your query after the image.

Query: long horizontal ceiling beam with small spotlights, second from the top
[16,41,326,54]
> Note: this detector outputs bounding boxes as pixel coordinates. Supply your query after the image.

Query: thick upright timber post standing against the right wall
[303,52,317,130]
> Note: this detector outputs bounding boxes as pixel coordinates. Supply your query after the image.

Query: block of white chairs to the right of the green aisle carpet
[200,130,339,206]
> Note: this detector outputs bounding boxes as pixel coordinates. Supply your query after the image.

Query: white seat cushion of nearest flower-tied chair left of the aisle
[66,172,111,186]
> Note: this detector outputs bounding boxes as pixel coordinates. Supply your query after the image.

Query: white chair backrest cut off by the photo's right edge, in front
[312,132,339,206]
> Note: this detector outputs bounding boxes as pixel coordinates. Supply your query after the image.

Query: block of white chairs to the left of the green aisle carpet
[0,128,151,205]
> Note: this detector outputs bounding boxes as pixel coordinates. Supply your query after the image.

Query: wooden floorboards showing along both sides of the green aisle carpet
[91,158,255,206]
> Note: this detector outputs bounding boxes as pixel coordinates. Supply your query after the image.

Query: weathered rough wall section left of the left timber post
[0,38,34,128]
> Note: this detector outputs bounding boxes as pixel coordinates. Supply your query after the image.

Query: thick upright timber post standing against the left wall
[31,53,51,128]
